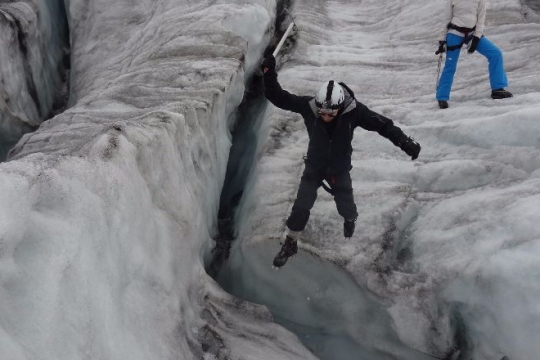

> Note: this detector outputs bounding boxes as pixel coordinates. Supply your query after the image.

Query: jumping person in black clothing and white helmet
[261,55,420,267]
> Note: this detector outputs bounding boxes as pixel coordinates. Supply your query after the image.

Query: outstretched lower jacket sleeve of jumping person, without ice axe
[356,101,408,146]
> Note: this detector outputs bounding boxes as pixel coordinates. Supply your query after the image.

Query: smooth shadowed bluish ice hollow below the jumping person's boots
[217,242,433,360]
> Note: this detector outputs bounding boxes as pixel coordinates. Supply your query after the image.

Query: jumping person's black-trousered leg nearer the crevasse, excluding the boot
[286,166,321,232]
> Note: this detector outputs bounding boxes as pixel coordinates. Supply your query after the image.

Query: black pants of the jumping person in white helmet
[287,165,358,231]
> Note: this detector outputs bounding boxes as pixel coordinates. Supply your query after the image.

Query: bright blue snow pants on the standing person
[436,34,508,101]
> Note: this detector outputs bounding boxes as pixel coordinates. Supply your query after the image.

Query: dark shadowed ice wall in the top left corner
[0,0,69,160]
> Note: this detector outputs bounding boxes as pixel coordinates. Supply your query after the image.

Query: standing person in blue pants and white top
[435,0,512,109]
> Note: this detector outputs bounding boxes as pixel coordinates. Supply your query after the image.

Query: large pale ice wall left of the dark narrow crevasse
[0,0,318,360]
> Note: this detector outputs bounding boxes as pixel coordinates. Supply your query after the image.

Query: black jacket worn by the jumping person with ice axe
[264,70,408,176]
